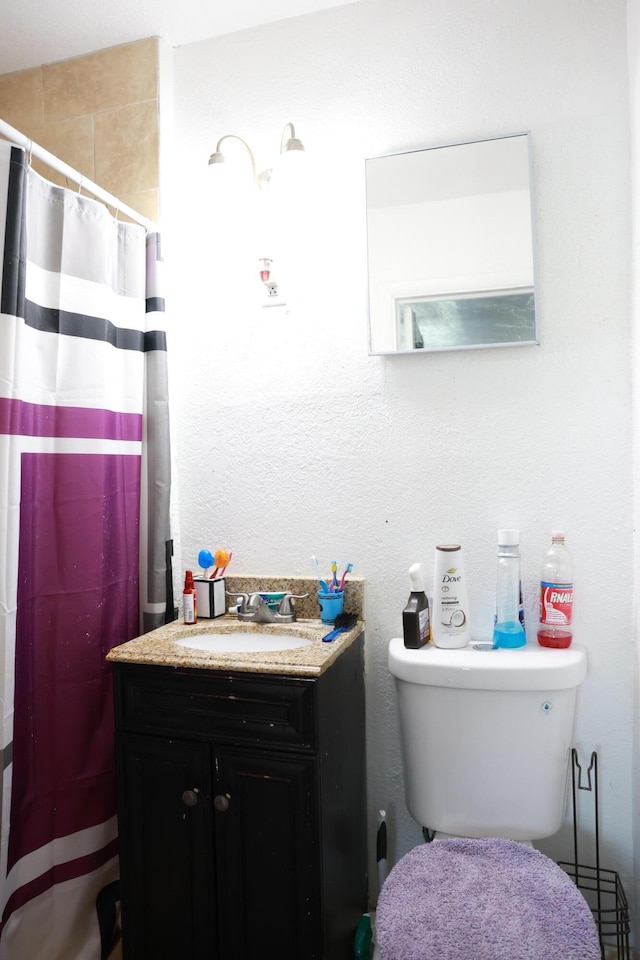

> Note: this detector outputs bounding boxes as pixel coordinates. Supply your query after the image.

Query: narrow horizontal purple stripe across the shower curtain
[0,397,142,440]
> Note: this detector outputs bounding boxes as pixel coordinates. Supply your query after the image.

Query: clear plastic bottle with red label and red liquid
[538,530,573,649]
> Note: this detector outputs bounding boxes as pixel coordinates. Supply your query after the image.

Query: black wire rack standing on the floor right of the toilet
[559,749,631,960]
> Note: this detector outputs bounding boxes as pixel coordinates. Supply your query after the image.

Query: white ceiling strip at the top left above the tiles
[0,0,356,75]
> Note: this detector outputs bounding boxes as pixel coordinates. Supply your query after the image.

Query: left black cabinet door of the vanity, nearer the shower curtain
[118,734,216,960]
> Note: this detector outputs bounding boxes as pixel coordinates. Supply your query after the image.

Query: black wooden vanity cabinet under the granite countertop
[112,636,367,960]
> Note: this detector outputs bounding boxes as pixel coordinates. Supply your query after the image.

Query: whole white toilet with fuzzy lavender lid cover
[374,638,600,960]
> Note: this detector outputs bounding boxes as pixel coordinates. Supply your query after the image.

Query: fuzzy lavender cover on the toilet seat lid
[376,840,600,960]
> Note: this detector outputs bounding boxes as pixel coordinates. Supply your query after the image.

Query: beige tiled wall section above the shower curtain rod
[0,37,159,220]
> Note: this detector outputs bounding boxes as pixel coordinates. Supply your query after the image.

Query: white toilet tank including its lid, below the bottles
[389,638,587,841]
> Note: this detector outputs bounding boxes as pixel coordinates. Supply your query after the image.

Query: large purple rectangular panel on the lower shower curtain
[9,453,140,882]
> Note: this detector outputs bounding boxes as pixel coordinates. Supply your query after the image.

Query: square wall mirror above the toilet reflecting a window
[365,133,538,354]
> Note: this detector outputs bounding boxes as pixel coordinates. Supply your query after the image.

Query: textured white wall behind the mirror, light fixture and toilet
[164,0,634,916]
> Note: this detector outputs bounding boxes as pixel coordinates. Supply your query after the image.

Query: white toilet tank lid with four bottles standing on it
[389,637,587,690]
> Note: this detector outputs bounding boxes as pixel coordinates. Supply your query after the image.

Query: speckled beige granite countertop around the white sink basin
[107,615,364,677]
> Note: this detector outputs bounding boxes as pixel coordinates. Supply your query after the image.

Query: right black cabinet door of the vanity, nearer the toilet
[214,749,322,960]
